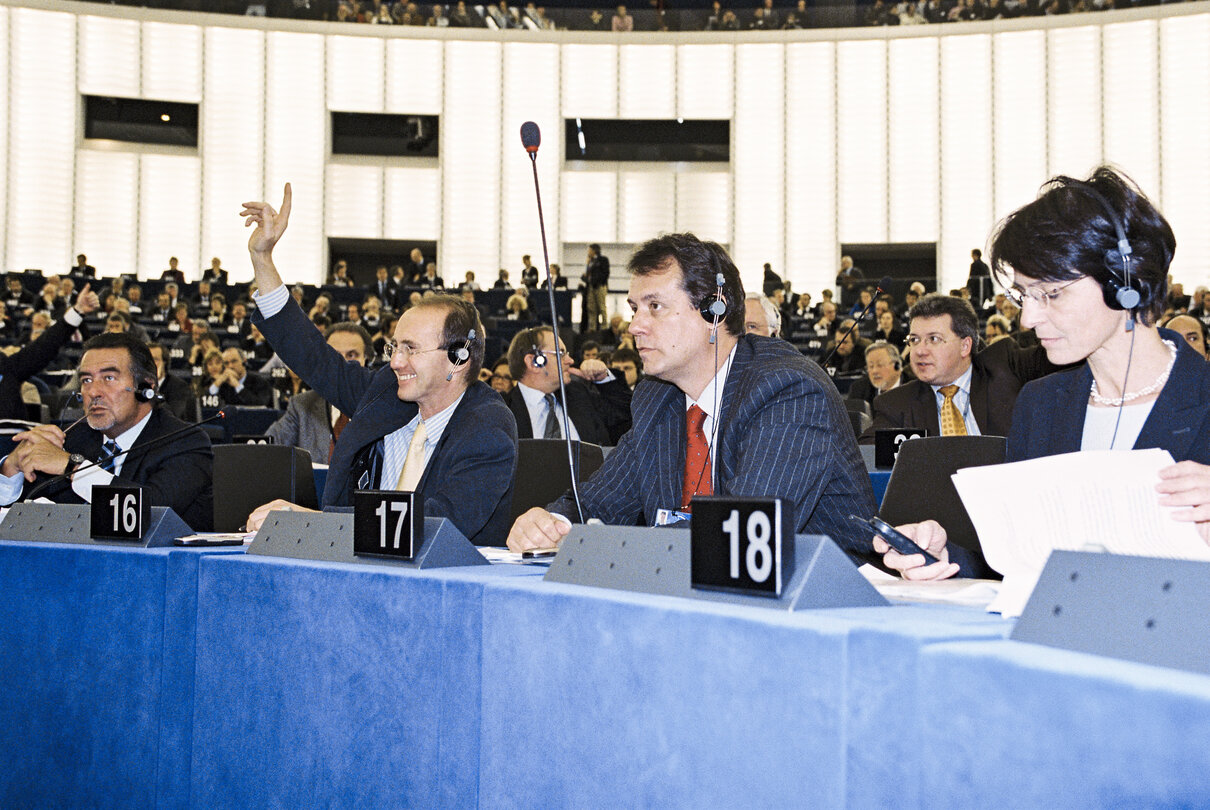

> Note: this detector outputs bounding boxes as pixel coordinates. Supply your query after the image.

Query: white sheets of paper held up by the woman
[953,449,1210,616]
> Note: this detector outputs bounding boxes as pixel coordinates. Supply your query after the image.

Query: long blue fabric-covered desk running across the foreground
[0,544,1210,808]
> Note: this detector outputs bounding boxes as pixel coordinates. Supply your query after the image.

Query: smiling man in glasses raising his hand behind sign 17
[242,184,517,545]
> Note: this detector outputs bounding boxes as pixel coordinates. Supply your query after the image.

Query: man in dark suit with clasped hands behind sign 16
[0,333,214,532]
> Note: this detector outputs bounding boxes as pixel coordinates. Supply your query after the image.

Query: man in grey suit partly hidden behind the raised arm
[265,322,374,464]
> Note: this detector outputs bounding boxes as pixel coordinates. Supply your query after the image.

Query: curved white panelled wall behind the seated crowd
[0,0,1210,296]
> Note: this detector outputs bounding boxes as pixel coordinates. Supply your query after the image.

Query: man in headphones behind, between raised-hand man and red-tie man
[505,327,630,446]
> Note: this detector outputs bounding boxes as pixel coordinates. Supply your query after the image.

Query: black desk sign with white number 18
[690,495,794,597]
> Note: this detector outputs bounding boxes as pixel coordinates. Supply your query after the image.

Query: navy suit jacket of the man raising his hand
[253,294,517,546]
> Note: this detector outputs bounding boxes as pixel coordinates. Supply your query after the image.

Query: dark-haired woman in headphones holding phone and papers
[875,167,1210,580]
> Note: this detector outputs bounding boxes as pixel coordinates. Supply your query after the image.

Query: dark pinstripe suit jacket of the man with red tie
[548,335,877,555]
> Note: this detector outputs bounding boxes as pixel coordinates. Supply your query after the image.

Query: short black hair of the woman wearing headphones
[991,166,1176,324]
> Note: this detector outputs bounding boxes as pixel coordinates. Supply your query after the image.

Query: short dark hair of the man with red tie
[629,234,744,337]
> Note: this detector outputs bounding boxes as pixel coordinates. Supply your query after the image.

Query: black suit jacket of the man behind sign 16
[25,407,214,532]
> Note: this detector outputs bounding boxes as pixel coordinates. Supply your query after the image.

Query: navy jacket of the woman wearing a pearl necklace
[1006,329,1210,464]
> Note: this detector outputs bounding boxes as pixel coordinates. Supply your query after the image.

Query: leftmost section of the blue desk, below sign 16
[0,542,238,808]
